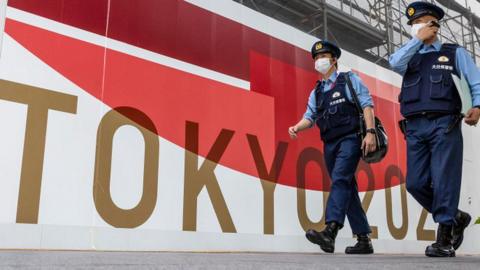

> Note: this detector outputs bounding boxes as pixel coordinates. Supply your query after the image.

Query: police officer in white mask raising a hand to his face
[390,2,480,257]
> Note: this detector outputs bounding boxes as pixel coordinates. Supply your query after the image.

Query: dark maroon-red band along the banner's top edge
[8,0,312,80]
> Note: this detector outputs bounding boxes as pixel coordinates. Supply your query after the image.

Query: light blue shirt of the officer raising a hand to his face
[389,37,480,106]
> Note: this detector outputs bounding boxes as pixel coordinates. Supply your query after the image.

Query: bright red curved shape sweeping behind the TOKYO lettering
[6,6,405,190]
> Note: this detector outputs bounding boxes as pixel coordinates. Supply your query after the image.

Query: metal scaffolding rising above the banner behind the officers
[233,0,480,68]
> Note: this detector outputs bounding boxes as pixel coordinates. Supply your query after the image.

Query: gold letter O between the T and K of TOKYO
[93,107,159,228]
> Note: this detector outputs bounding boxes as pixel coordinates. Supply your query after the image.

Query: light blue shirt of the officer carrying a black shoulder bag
[303,71,373,125]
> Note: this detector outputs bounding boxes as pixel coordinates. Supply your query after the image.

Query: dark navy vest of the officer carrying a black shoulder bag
[315,73,360,142]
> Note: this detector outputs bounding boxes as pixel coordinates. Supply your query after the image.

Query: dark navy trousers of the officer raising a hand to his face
[406,115,463,225]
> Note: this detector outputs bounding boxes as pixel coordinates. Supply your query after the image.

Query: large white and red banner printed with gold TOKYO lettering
[0,0,480,254]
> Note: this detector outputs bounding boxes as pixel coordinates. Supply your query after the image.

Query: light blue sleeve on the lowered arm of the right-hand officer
[456,47,480,106]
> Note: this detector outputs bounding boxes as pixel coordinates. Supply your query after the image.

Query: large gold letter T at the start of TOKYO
[0,80,77,224]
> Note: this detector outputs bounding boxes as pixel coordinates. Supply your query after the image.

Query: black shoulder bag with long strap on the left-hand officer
[345,73,388,163]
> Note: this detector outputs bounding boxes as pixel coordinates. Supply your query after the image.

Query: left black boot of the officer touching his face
[425,224,455,257]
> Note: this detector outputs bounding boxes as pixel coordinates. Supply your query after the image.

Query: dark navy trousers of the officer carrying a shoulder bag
[324,134,371,235]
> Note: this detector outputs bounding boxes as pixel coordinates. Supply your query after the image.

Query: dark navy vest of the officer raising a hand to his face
[399,44,462,118]
